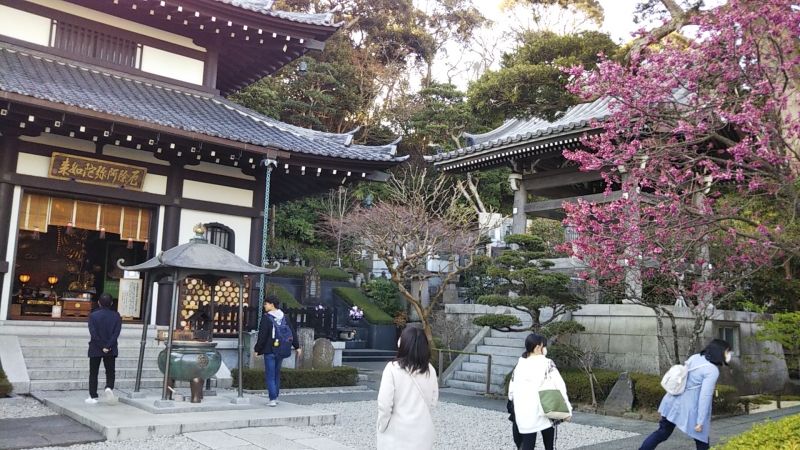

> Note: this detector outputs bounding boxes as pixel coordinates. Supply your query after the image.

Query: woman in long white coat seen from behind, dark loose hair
[378,327,439,450]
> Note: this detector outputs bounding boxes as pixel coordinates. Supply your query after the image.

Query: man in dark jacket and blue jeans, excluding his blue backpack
[253,295,302,406]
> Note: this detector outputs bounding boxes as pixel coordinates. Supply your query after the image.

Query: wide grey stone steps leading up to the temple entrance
[0,321,164,392]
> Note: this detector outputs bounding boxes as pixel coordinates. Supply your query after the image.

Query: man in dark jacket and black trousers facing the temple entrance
[86,293,122,404]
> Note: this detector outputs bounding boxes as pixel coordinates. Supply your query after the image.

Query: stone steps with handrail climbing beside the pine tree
[444,330,530,394]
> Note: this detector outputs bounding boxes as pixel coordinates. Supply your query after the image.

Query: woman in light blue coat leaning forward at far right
[639,339,731,450]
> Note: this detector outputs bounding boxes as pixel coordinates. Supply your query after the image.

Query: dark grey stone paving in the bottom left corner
[0,416,105,449]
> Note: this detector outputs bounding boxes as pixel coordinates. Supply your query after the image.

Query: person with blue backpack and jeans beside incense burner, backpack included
[253,295,303,407]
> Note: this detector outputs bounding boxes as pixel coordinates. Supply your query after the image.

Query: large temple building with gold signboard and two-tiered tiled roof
[0,0,405,335]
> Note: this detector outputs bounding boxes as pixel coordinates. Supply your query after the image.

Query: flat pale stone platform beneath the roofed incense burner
[34,391,336,441]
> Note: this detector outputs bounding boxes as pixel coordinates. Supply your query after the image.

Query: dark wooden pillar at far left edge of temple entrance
[0,130,19,304]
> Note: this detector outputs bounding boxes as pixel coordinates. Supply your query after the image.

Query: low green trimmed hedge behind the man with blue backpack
[231,366,358,390]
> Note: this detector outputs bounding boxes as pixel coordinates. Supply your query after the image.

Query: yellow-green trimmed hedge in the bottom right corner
[714,414,800,450]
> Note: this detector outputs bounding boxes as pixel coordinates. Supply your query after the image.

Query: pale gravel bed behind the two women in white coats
[309,401,636,450]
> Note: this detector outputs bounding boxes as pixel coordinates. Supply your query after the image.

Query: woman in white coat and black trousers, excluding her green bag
[508,333,572,450]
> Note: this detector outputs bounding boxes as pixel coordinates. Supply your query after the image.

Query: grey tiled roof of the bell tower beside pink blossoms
[425,97,611,163]
